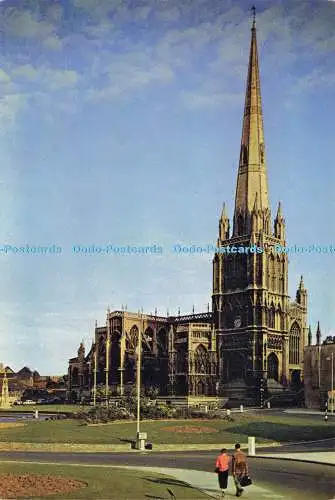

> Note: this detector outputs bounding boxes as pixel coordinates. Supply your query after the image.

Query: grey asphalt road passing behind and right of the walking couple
[0,440,335,500]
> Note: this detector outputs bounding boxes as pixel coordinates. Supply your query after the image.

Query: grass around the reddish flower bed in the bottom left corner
[0,462,208,500]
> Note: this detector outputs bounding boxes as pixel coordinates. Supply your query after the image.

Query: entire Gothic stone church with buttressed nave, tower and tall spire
[68,16,308,401]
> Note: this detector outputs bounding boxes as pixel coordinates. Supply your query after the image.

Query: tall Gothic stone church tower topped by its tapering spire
[212,13,307,399]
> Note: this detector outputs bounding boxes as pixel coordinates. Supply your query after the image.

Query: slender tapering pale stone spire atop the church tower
[234,7,270,235]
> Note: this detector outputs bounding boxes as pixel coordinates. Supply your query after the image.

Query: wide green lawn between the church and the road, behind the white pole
[0,414,335,444]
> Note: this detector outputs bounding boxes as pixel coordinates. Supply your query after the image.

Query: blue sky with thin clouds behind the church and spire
[0,0,335,374]
